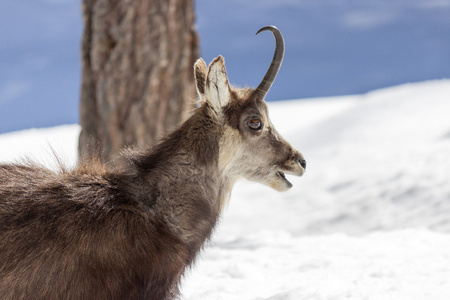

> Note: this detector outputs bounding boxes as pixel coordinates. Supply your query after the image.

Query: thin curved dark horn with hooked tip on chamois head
[256,25,284,99]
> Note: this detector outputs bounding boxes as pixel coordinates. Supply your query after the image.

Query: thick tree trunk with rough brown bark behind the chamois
[79,0,198,161]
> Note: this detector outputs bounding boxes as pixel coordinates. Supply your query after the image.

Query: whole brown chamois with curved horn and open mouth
[0,26,306,300]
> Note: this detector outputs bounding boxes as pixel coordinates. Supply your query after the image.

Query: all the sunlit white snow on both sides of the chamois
[0,80,450,300]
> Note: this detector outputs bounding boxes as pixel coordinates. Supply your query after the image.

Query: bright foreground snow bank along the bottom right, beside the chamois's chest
[184,230,450,300]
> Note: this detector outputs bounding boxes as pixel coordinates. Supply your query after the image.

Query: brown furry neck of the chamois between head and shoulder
[114,106,231,246]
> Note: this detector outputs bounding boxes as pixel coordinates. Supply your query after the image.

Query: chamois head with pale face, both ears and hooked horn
[194,26,306,191]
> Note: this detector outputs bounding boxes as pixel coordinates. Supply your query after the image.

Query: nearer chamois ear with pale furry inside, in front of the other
[206,55,230,112]
